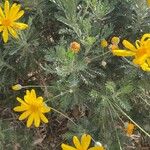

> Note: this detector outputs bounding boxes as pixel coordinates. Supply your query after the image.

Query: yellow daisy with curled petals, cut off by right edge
[112,34,150,71]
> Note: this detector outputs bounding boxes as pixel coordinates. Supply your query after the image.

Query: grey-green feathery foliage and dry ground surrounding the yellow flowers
[0,0,150,150]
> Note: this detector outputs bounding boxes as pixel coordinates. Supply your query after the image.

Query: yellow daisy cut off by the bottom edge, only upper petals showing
[61,134,104,150]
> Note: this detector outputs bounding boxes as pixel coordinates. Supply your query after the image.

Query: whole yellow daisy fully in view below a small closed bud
[14,89,50,127]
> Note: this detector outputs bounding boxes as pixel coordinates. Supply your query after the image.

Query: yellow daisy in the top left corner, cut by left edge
[0,0,28,43]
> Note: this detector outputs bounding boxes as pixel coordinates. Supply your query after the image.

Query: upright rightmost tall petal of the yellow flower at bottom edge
[81,134,91,149]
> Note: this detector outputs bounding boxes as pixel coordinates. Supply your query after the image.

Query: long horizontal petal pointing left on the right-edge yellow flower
[112,49,135,56]
